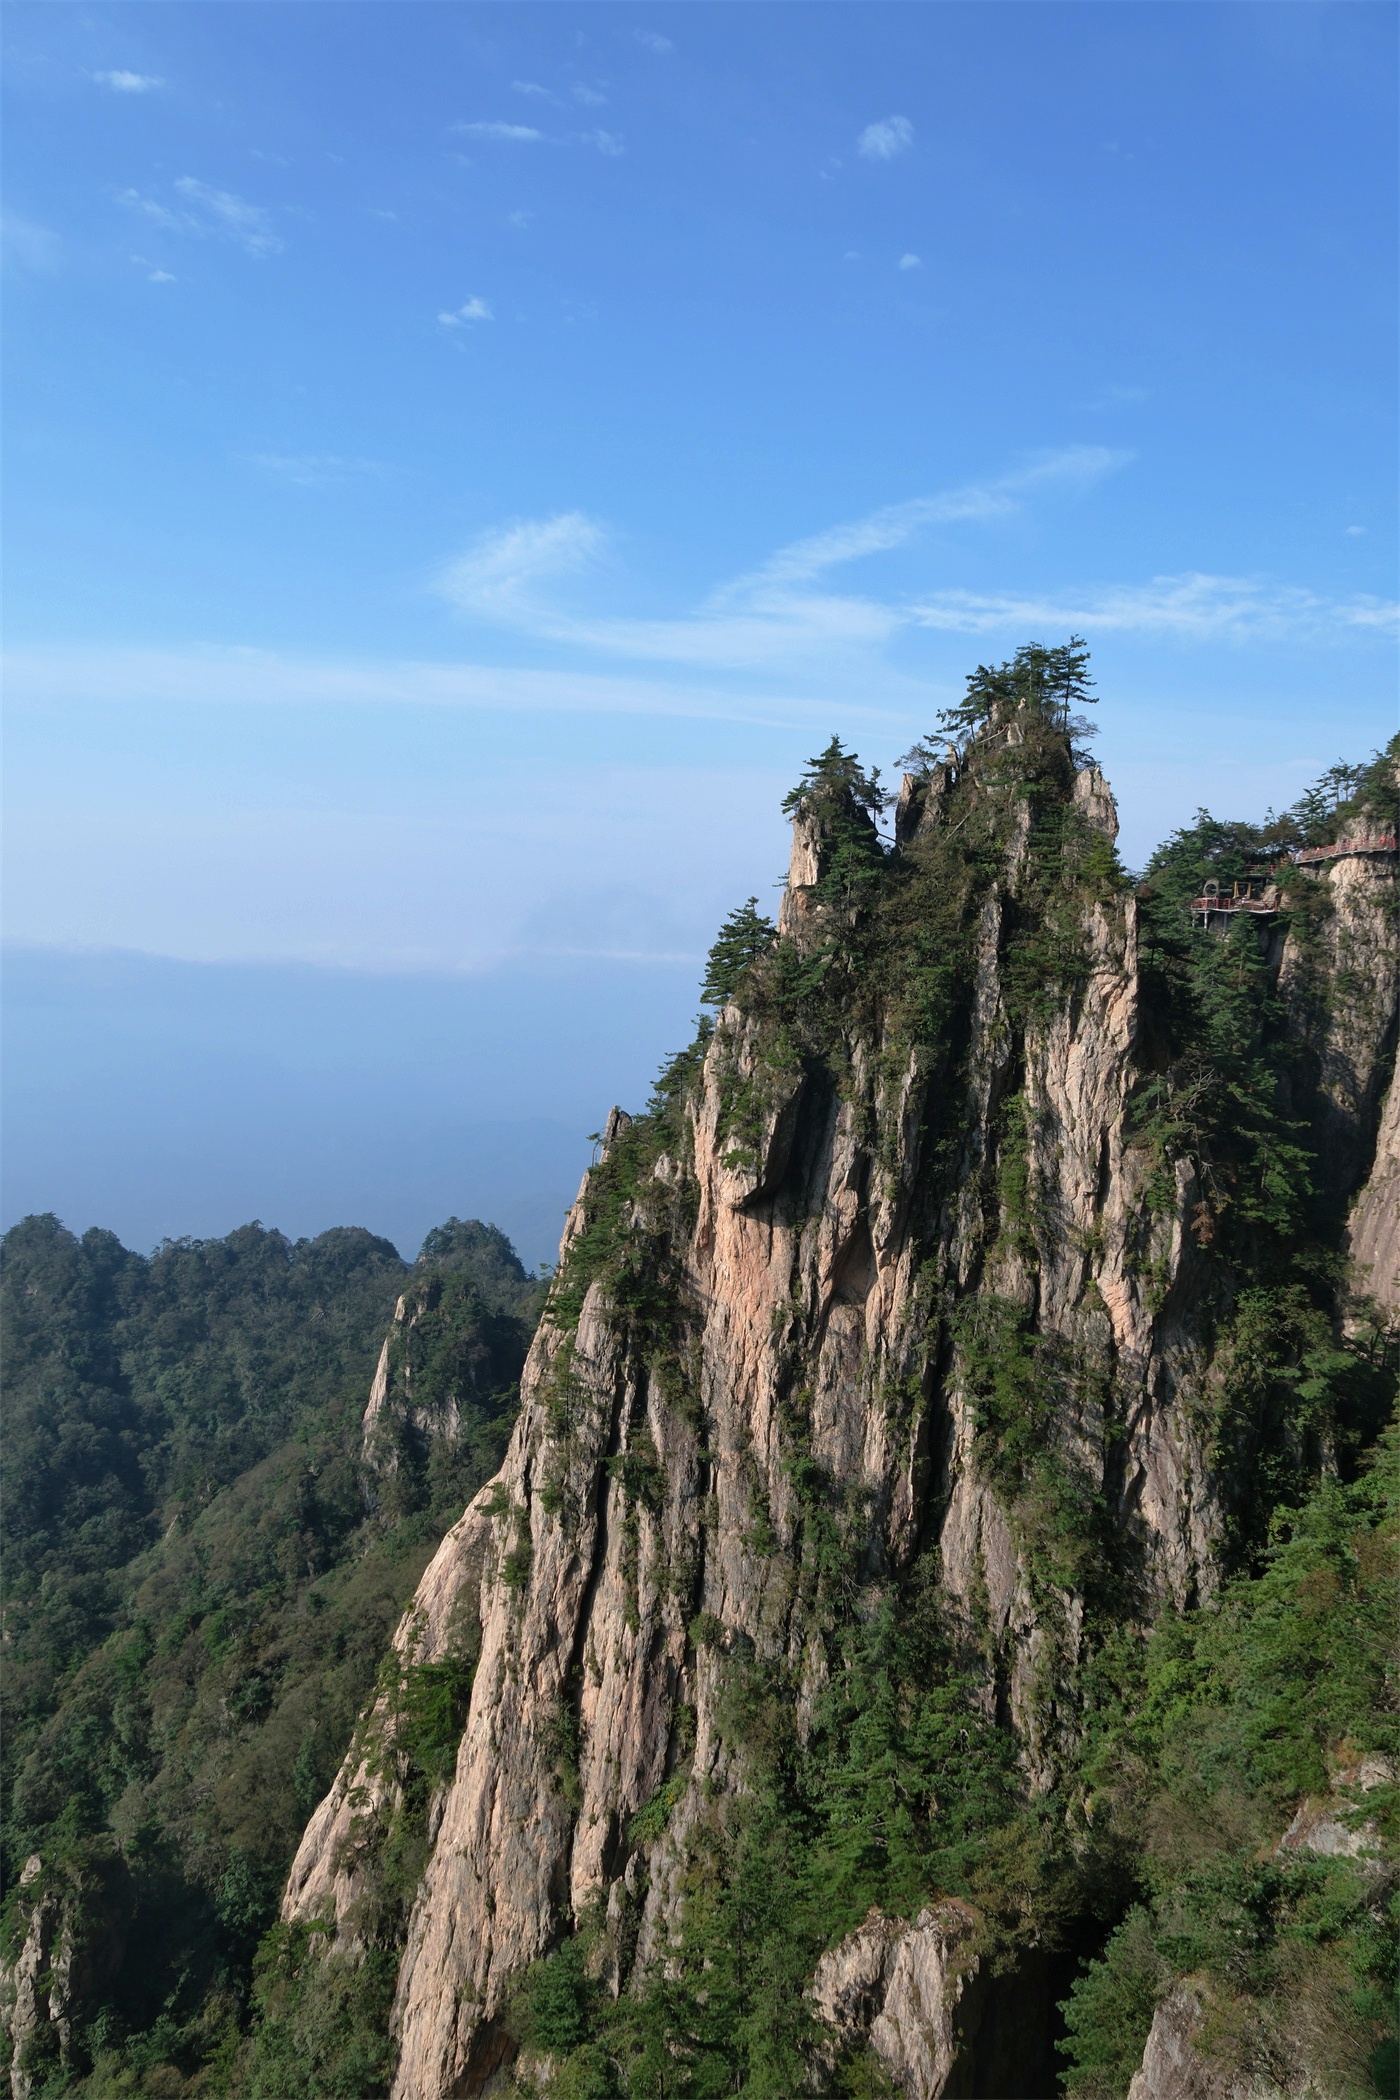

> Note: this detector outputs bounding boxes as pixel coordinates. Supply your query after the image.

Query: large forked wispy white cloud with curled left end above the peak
[437,445,1396,672]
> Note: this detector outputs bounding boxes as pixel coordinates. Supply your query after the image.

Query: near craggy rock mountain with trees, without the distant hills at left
[268,663,1400,2100]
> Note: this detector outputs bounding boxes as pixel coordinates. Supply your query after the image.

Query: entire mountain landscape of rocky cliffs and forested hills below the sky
[4,643,1400,2100]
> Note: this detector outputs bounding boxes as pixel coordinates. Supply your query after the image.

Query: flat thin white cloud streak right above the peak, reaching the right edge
[909,571,1400,641]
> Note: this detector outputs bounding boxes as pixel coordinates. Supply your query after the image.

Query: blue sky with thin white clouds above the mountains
[6,0,1396,1260]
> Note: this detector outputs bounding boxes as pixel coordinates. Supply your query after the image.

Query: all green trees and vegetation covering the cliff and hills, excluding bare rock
[4,641,1400,2100]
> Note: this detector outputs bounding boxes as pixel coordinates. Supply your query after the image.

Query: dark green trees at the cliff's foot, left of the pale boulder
[521,1565,1037,2100]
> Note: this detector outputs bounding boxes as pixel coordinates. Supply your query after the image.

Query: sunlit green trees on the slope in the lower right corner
[1066,1430,1400,2100]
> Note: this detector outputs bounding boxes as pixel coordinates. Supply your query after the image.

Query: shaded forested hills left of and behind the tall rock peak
[0,1218,537,2094]
